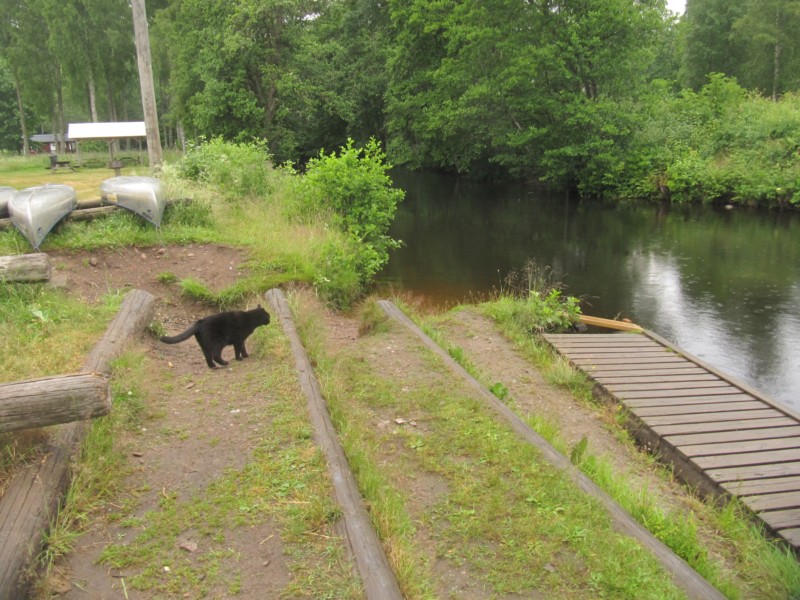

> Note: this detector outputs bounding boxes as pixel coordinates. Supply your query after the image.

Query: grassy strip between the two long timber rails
[294,290,682,598]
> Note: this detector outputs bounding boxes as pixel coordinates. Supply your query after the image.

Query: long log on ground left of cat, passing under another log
[0,290,155,600]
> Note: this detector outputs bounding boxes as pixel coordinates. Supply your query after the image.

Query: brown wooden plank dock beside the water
[544,330,800,555]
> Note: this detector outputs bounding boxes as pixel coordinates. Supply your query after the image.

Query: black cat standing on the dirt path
[159,304,269,369]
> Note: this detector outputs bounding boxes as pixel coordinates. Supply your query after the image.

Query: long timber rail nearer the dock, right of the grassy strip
[388,300,724,600]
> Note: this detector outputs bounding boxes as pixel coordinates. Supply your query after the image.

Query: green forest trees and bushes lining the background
[0,0,800,207]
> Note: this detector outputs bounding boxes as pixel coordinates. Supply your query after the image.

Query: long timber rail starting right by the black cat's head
[266,289,403,600]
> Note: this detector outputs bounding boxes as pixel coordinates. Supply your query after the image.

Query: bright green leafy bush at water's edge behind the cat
[295,139,404,307]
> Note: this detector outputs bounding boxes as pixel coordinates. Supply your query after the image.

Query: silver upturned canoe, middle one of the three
[8,183,78,250]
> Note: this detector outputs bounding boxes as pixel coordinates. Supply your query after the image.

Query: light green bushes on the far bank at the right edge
[615,75,800,207]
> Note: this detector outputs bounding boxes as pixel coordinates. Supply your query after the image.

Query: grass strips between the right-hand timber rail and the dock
[468,298,800,598]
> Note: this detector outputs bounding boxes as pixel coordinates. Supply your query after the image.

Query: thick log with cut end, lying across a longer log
[0,373,111,433]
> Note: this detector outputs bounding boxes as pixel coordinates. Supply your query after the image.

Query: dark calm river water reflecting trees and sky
[381,172,800,410]
